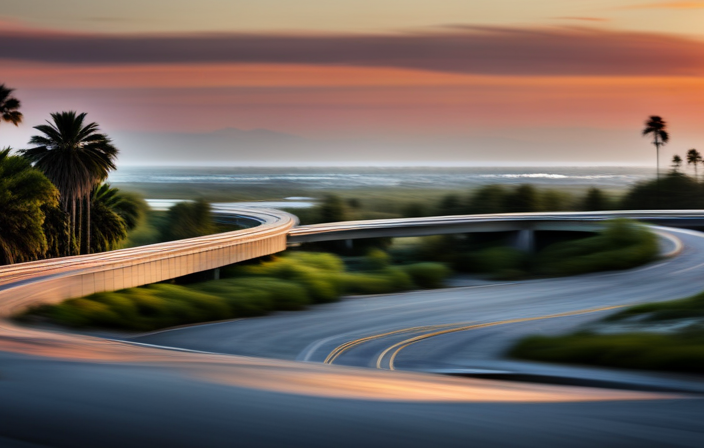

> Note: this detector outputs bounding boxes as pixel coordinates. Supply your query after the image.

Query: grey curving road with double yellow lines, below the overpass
[133,229,704,371]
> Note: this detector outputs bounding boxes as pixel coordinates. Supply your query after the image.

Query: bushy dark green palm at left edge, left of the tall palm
[0,148,59,264]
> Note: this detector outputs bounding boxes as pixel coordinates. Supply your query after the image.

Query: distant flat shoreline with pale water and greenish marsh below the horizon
[109,167,654,202]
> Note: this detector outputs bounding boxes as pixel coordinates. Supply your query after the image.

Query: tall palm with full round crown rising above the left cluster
[21,111,118,253]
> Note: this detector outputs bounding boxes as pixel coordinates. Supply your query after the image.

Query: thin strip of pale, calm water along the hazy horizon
[109,167,654,190]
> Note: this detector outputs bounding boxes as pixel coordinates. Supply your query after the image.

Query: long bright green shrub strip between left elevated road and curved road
[20,252,450,331]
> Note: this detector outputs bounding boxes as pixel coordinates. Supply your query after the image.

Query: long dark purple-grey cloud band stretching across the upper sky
[0,26,704,76]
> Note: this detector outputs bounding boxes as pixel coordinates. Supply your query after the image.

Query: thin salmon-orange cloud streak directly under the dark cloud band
[3,62,490,89]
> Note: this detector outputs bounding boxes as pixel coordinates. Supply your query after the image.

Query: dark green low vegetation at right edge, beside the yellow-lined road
[510,293,704,373]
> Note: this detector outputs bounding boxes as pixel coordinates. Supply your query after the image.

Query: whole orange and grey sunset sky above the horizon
[0,0,704,166]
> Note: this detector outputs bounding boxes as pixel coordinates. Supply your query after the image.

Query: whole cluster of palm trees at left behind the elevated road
[0,84,146,264]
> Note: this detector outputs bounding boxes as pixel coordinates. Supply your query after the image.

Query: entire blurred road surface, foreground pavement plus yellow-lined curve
[0,215,704,447]
